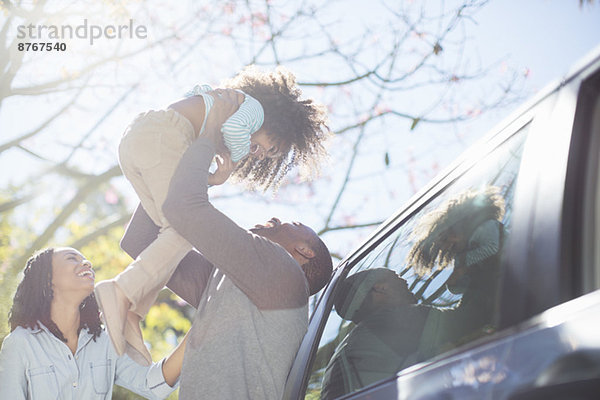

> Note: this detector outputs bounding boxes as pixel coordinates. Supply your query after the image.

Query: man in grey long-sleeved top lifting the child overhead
[121,91,332,399]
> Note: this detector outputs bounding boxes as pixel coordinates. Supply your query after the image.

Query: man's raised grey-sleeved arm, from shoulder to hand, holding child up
[163,90,308,308]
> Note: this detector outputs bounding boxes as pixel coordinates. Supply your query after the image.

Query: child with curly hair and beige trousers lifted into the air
[96,67,328,363]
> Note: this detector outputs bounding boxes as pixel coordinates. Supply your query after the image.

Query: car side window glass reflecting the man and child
[306,125,529,400]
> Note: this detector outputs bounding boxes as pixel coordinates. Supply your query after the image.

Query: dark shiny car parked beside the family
[284,45,600,400]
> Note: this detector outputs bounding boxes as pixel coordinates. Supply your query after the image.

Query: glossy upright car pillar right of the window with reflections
[501,55,600,329]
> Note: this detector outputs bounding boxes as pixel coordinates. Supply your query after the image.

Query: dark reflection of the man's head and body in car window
[321,268,439,399]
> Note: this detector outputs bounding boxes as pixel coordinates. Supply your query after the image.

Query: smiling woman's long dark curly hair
[8,248,102,342]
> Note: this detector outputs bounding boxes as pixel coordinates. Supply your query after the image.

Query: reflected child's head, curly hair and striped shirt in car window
[407,186,504,293]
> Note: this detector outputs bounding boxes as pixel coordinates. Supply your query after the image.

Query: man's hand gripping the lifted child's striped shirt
[201,89,244,154]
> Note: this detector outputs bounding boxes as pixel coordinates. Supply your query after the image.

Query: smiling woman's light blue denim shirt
[0,324,173,400]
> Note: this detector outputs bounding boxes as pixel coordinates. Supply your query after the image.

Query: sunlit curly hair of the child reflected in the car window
[406,186,504,276]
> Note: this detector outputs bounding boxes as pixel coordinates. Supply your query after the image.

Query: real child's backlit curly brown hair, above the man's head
[223,66,330,190]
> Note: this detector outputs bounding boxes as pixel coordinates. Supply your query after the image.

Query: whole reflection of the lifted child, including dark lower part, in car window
[407,186,504,347]
